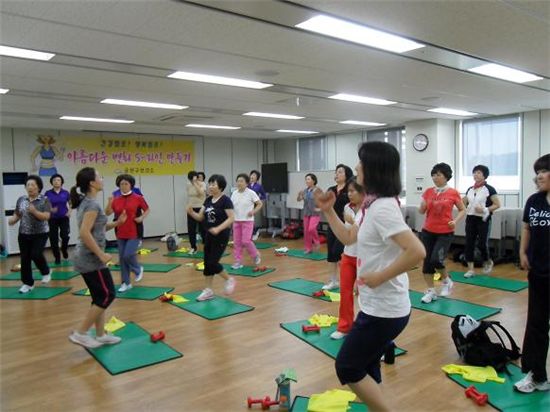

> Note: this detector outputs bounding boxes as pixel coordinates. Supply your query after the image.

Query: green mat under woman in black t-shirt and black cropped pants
[169,291,254,320]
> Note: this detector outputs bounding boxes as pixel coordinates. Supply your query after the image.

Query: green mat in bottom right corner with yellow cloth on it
[448,364,550,412]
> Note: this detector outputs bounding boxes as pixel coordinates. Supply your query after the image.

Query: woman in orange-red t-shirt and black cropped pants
[418,163,466,303]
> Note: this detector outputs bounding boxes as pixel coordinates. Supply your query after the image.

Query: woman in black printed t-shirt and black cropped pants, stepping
[187,175,235,301]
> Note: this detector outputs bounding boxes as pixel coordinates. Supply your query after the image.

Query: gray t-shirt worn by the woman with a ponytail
[74,197,107,273]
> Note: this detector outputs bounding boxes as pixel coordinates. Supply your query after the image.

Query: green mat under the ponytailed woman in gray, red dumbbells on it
[86,322,183,375]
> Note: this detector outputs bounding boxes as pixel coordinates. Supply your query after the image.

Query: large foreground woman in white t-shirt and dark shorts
[317,142,426,411]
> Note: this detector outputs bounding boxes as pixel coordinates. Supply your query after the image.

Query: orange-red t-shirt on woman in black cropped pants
[422,187,462,233]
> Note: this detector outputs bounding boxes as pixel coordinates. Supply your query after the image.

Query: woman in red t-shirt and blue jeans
[106,174,149,292]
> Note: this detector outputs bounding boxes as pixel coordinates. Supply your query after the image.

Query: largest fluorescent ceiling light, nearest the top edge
[296,15,424,53]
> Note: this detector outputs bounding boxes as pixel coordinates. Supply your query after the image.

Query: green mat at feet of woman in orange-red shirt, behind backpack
[409,290,502,320]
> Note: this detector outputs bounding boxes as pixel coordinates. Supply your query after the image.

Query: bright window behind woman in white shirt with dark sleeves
[459,115,520,192]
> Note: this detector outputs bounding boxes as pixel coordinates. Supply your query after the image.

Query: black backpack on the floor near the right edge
[451,315,521,372]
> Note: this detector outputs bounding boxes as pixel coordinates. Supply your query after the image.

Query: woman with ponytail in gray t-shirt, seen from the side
[69,167,126,348]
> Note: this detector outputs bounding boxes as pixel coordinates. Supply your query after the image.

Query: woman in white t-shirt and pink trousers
[231,173,262,269]
